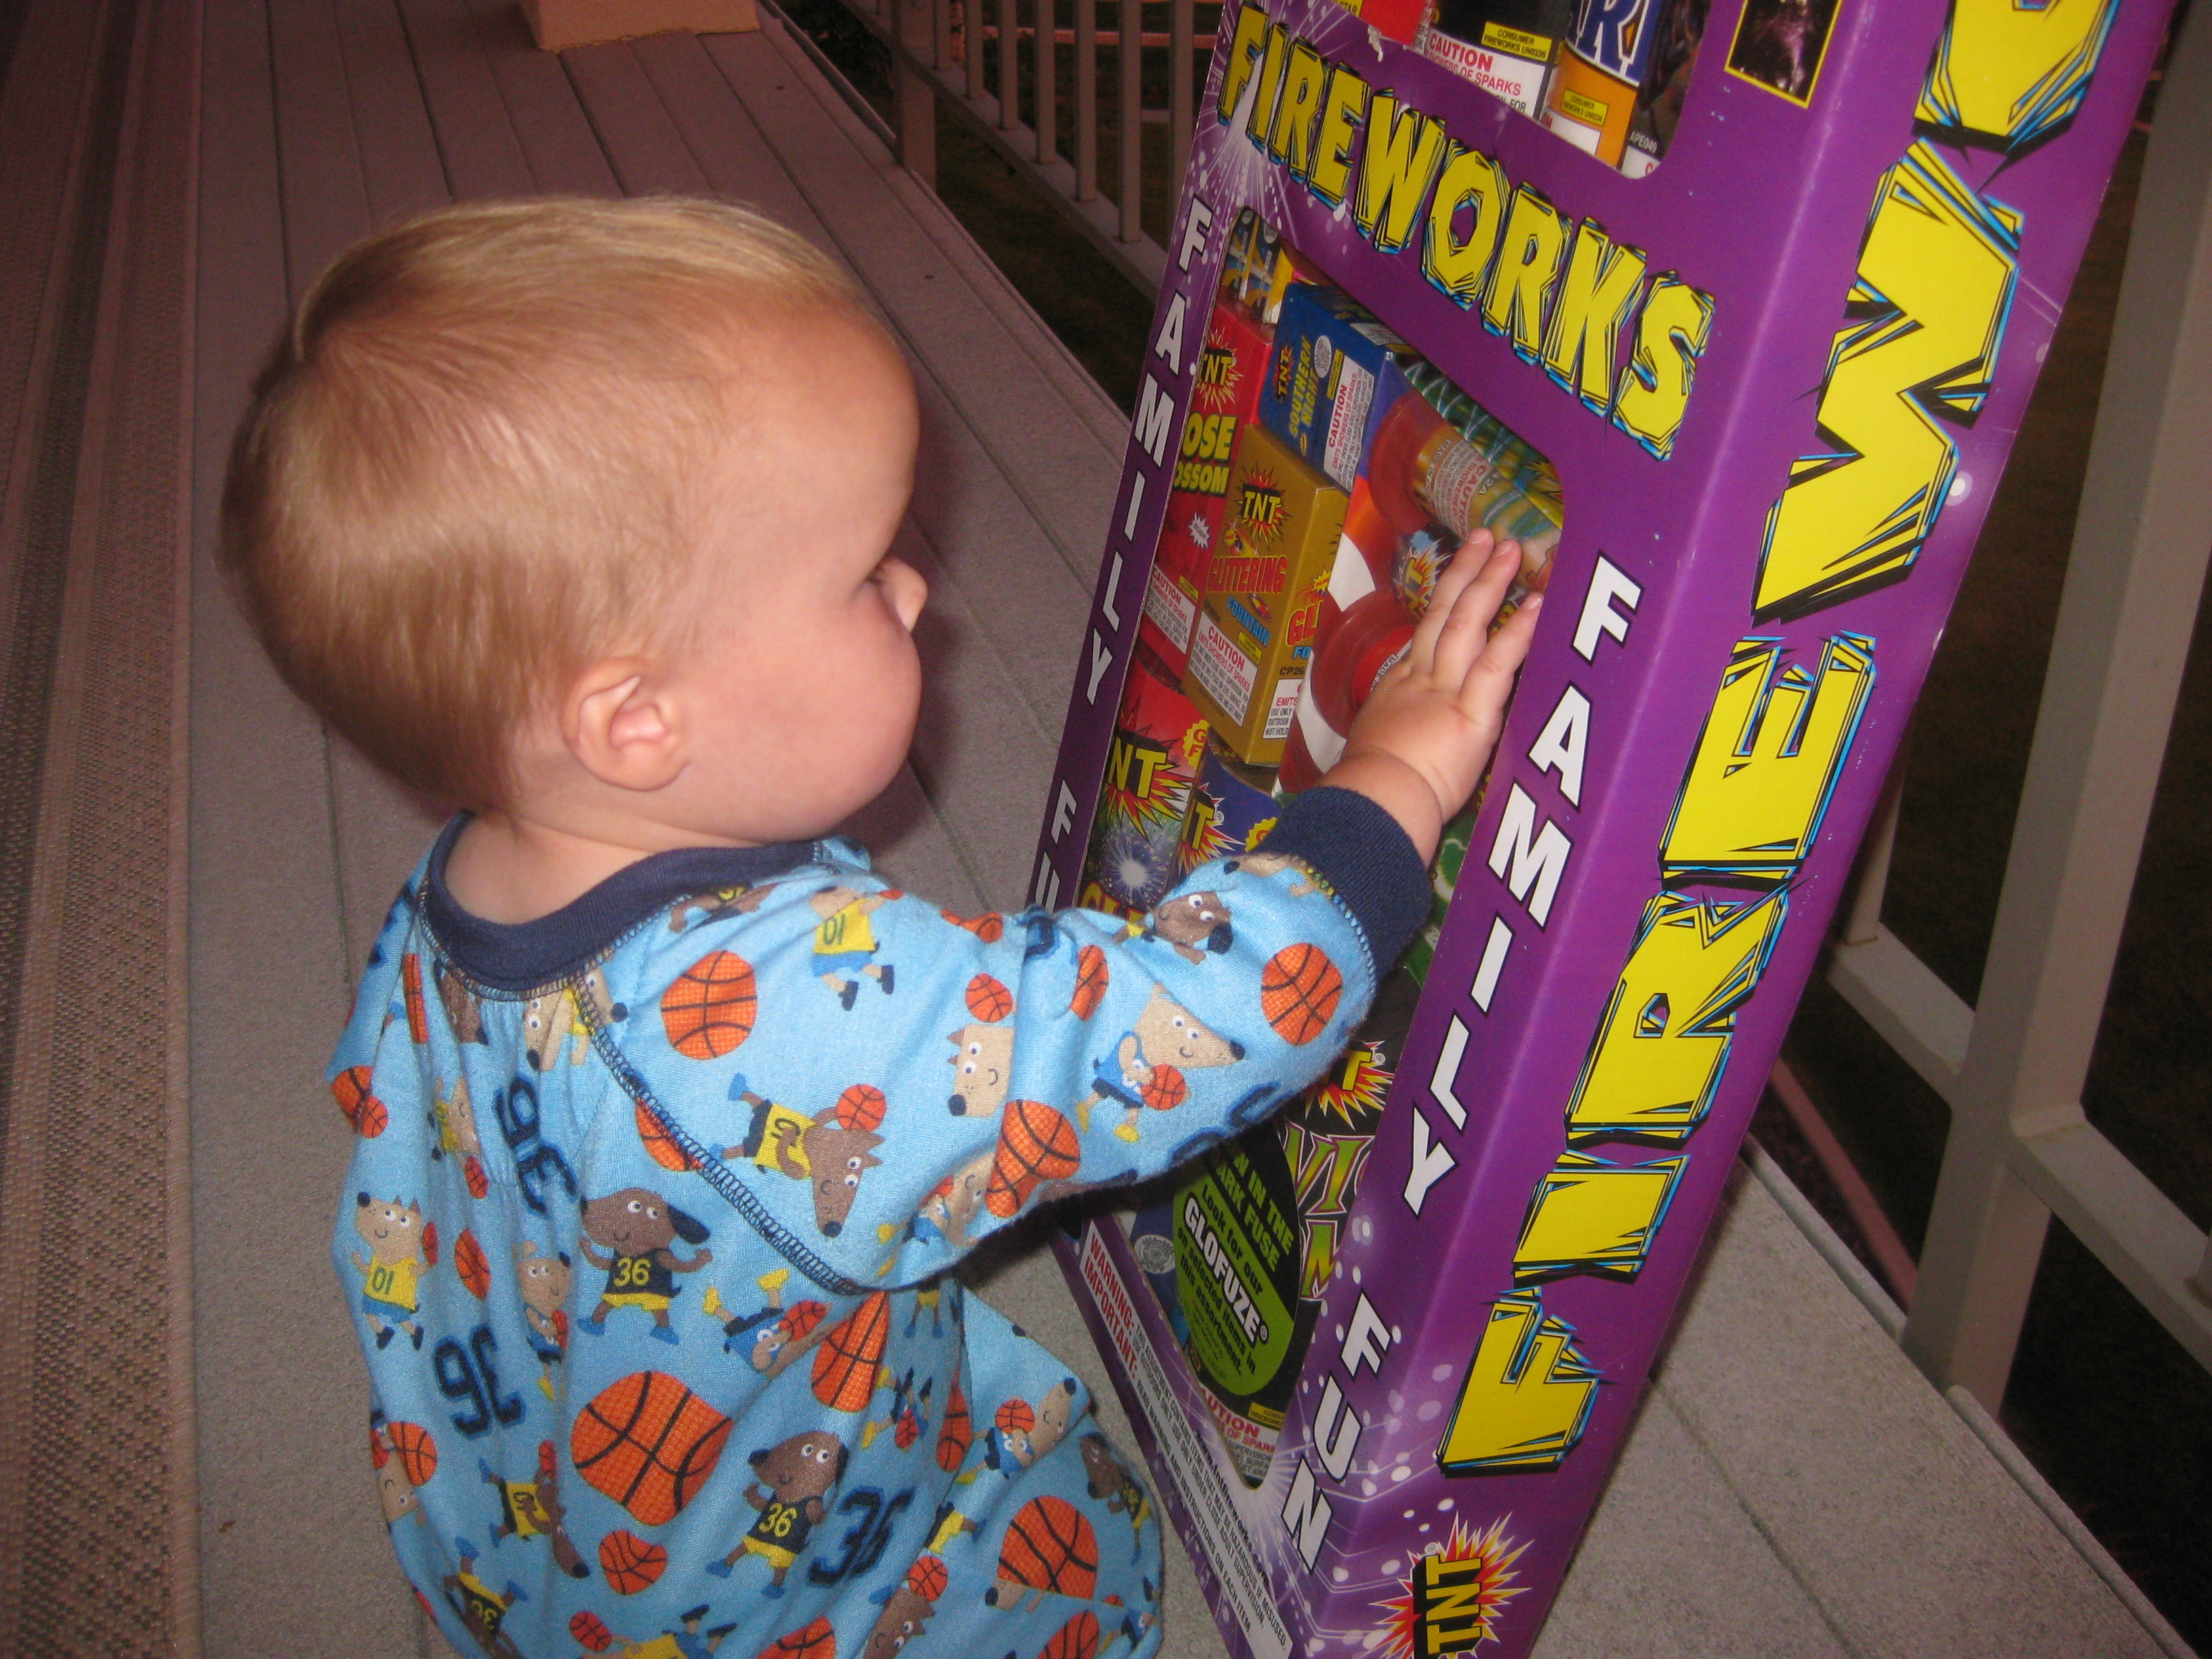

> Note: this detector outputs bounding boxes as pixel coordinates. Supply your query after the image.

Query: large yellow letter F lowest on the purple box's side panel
[1435,1290,1599,1475]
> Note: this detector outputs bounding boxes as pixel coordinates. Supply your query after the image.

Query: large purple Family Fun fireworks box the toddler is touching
[1031,0,2176,1659]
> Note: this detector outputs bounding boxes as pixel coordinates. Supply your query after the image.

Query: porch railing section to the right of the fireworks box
[1827,7,2212,1411]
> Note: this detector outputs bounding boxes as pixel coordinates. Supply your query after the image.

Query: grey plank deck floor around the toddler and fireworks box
[172,0,2156,1659]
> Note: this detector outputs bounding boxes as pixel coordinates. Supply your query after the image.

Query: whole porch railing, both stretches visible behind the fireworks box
[794,0,2212,1411]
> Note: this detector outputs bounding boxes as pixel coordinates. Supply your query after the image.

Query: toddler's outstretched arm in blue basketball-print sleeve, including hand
[609,537,1533,1294]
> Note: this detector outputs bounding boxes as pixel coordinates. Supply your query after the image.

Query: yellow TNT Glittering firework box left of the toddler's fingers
[1183,425,1345,765]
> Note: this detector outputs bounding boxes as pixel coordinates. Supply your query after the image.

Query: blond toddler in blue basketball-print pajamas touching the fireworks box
[221,201,1537,1659]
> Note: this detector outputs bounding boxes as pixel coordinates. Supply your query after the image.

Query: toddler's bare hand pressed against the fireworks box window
[1321,531,1544,863]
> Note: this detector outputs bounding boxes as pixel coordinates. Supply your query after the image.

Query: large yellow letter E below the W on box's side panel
[1659,633,1874,880]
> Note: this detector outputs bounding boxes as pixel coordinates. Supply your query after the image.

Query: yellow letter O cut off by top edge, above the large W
[1913,0,2119,150]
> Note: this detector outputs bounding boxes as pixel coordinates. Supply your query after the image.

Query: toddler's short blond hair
[219,199,874,810]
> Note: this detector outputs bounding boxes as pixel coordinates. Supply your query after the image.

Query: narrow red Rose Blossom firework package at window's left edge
[1141,305,1270,675]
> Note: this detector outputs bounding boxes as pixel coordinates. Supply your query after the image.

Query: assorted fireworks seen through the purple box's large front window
[1084,224,1561,1513]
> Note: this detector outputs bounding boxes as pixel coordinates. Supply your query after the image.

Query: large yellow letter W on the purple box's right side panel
[1754,144,2020,617]
